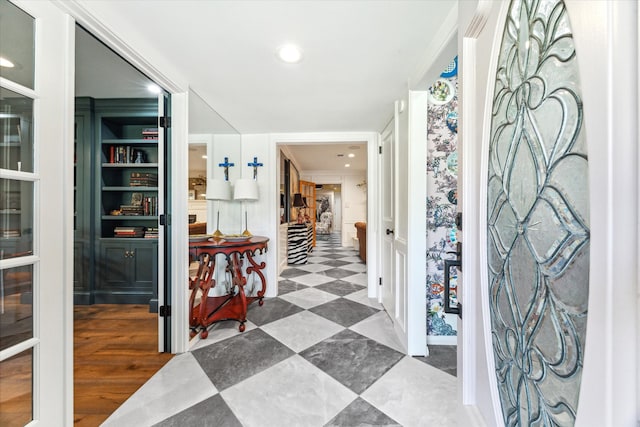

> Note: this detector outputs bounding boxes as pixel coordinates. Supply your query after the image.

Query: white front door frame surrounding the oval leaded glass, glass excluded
[458,0,640,426]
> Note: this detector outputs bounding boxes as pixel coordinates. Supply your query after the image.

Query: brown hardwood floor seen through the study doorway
[74,304,172,427]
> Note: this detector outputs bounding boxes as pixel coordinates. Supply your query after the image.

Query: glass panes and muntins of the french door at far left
[0,0,39,426]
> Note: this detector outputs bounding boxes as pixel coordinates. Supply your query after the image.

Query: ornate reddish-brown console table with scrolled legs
[189,236,269,338]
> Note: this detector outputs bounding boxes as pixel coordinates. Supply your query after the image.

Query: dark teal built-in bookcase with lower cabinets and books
[78,98,162,312]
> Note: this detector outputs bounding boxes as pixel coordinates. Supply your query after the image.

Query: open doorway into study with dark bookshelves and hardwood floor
[74,25,171,425]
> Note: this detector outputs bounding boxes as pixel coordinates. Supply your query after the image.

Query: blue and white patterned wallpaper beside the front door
[426,58,458,336]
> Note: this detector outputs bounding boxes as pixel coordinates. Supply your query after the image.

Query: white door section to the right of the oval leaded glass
[565,0,638,426]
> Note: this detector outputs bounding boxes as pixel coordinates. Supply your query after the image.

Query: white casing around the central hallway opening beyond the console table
[267,132,380,298]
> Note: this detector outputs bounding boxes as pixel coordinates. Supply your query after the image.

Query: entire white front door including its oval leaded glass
[459,0,639,426]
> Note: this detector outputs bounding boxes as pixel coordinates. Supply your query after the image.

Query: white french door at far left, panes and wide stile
[0,0,74,426]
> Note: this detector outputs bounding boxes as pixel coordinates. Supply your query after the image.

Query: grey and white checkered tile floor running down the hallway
[103,235,456,427]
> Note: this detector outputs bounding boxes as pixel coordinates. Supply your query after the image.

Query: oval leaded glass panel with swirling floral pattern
[487,0,589,426]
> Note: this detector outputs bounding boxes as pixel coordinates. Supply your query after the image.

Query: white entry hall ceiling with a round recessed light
[77,0,457,133]
